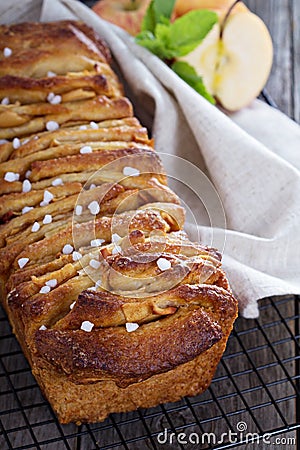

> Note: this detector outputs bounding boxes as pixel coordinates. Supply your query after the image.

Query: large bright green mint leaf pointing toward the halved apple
[170,10,218,56]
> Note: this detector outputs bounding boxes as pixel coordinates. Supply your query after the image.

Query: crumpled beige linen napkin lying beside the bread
[0,0,300,318]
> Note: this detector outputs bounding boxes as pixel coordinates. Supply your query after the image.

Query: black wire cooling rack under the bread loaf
[0,297,300,450]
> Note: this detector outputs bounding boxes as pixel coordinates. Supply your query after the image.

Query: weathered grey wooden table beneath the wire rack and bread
[0,0,300,450]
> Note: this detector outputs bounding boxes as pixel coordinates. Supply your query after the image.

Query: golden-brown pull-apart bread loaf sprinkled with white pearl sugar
[0,21,237,423]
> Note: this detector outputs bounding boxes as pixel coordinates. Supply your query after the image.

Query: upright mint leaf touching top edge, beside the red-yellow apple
[141,0,176,33]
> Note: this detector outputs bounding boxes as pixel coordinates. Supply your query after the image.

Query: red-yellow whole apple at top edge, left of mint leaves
[93,0,151,36]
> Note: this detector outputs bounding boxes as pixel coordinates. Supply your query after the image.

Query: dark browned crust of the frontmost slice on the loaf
[35,308,222,387]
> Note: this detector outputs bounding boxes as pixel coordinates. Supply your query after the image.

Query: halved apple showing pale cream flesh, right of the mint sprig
[180,10,273,111]
